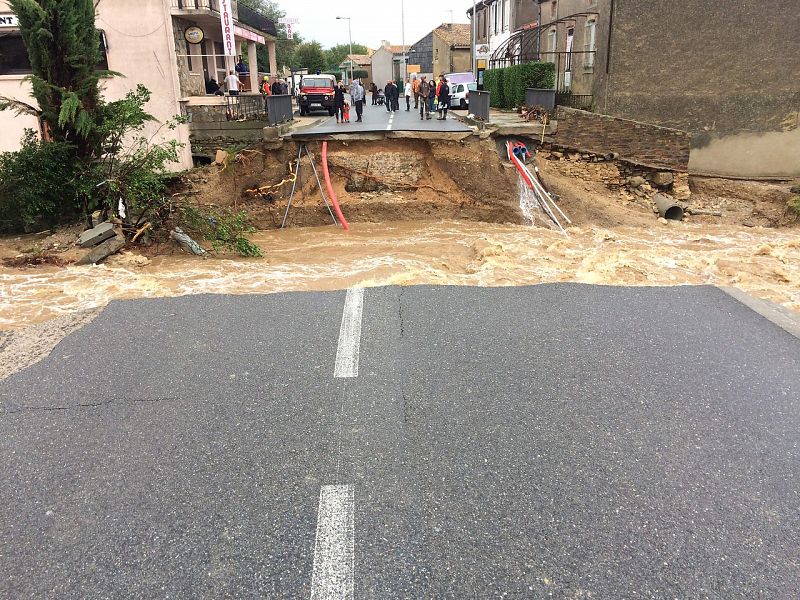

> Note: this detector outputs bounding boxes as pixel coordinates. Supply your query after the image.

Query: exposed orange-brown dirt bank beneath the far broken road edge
[179,140,520,229]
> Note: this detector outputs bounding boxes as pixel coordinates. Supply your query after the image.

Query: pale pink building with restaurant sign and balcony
[0,0,277,168]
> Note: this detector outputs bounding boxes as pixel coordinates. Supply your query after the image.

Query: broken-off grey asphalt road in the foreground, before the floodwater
[0,284,800,599]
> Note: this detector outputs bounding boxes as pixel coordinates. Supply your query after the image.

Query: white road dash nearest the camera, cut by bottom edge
[311,485,355,600]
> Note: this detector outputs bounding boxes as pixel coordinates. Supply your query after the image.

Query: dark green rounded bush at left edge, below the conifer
[0,129,76,231]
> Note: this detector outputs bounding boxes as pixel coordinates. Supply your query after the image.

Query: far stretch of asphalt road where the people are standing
[292,97,472,138]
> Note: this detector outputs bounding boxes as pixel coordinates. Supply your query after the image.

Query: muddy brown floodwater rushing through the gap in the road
[0,221,800,329]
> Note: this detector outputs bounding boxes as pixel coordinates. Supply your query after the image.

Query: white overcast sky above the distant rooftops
[278,0,472,48]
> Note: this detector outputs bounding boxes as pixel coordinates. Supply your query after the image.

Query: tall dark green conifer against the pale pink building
[7,0,104,158]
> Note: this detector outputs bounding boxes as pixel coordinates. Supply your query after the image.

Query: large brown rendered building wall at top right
[593,0,800,177]
